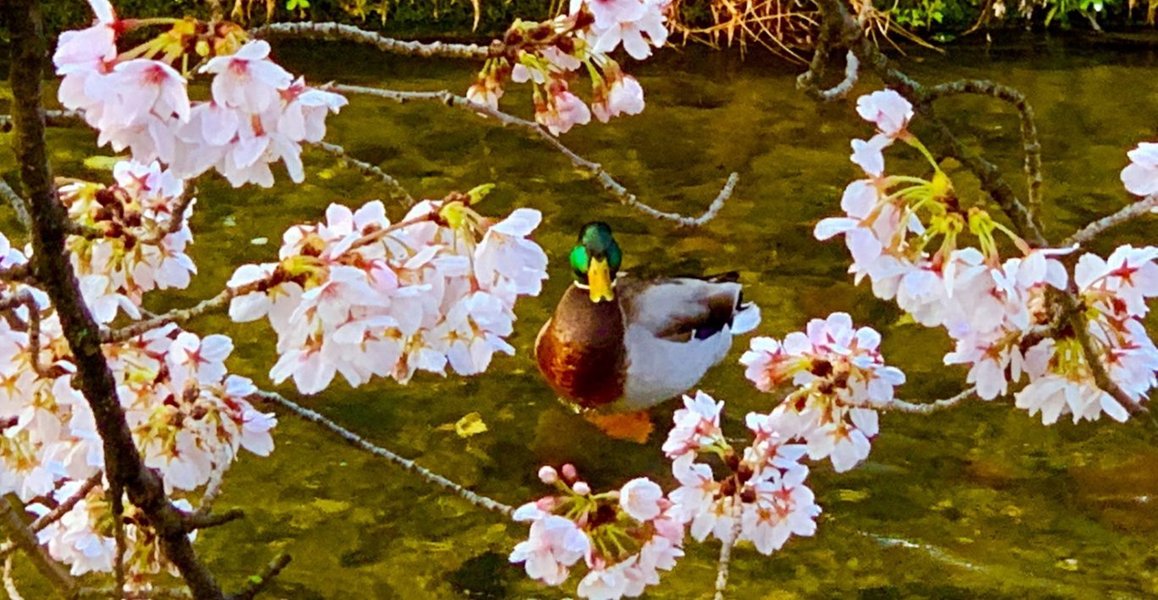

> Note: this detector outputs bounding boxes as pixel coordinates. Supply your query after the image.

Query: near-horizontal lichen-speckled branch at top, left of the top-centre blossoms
[249,22,493,60]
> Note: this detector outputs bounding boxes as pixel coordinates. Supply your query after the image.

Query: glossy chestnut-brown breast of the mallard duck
[535,286,626,408]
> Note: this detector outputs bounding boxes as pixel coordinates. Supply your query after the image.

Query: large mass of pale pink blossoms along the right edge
[815,90,1158,424]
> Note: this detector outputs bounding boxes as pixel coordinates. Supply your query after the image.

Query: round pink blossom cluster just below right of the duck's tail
[740,313,904,473]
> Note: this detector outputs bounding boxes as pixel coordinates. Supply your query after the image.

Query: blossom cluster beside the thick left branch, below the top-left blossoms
[60,161,197,323]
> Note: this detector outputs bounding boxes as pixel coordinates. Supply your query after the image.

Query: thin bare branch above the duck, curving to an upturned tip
[329,83,740,227]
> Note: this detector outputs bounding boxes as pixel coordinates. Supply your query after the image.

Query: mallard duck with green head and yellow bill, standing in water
[535,222,760,441]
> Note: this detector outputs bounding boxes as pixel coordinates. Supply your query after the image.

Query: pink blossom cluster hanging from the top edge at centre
[467,0,668,136]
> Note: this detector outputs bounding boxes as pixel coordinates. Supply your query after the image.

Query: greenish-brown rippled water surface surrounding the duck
[9,35,1158,600]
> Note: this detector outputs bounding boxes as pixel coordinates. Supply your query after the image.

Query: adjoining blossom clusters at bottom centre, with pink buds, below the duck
[511,392,820,599]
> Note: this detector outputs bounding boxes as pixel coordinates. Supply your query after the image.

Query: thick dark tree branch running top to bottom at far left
[3,0,223,600]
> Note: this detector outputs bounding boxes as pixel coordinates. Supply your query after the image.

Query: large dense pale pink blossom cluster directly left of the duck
[228,199,547,394]
